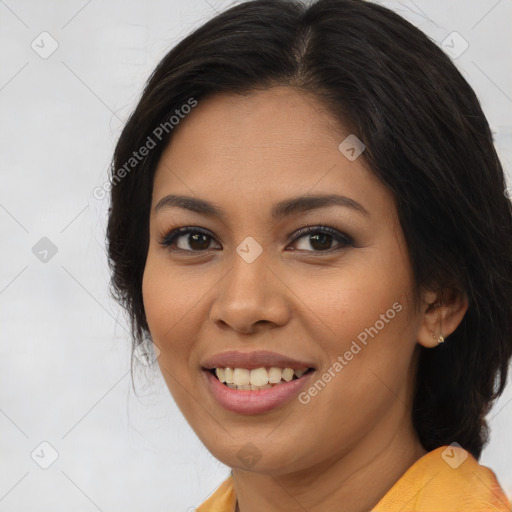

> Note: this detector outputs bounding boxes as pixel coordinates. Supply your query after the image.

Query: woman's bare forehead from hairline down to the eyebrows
[153,86,390,216]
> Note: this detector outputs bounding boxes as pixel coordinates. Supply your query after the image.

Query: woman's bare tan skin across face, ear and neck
[143,86,467,512]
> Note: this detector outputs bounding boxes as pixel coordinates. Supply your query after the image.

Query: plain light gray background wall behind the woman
[0,0,512,512]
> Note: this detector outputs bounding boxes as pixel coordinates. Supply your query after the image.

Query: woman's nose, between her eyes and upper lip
[210,254,290,334]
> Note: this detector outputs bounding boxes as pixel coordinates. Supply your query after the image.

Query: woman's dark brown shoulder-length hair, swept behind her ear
[107,0,512,459]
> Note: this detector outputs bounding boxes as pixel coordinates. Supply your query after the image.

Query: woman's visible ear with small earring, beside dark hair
[417,288,468,348]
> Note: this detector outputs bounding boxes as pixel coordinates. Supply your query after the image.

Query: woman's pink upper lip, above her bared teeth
[201,350,314,370]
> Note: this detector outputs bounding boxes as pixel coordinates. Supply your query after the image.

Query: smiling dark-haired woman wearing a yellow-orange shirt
[108,0,512,512]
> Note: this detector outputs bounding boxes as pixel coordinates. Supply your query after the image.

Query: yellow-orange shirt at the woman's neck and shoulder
[197,446,512,512]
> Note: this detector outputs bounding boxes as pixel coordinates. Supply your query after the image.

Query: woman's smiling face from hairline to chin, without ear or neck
[143,87,421,474]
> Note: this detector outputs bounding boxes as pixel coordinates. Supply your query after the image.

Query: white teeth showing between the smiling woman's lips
[203,366,315,391]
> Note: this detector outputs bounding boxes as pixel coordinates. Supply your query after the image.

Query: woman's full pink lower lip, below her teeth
[203,370,315,414]
